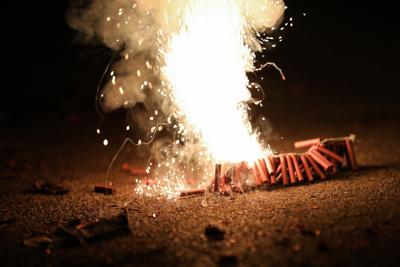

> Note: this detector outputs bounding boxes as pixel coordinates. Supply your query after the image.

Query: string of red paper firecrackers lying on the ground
[181,134,357,197]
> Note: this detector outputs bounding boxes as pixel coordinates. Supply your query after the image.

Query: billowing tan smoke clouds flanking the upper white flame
[67,0,285,111]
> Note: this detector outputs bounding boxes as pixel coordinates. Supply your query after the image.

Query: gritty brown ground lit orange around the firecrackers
[0,103,400,266]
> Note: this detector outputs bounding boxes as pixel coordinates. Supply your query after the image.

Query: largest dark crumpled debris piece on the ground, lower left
[54,210,131,244]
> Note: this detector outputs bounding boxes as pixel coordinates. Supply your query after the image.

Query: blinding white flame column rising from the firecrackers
[163,0,263,162]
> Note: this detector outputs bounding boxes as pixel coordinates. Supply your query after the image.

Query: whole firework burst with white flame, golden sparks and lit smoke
[68,0,292,198]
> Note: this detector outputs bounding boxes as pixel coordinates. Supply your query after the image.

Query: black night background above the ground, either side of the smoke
[0,1,400,128]
